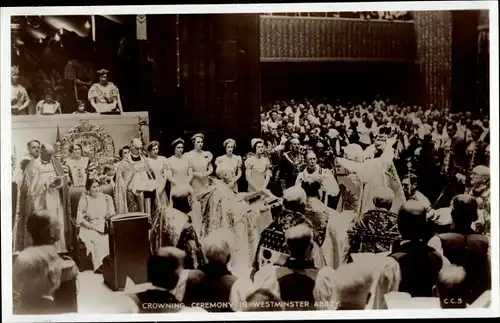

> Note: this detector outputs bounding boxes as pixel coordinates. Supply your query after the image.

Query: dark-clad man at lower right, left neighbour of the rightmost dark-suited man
[389,200,443,297]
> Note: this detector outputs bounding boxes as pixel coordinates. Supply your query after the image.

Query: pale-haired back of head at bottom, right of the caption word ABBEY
[333,262,373,310]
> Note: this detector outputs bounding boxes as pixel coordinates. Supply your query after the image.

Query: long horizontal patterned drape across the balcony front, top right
[260,16,416,61]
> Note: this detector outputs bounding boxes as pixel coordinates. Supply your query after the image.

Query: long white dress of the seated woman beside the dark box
[77,193,115,270]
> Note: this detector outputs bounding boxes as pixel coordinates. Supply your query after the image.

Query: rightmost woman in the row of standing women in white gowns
[245,138,271,192]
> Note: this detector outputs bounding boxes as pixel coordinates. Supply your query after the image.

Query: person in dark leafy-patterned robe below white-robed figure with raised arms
[348,188,401,256]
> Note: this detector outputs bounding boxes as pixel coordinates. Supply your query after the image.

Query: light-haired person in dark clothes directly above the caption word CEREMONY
[184,230,236,312]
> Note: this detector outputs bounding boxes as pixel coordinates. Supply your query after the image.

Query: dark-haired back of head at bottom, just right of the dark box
[148,247,186,290]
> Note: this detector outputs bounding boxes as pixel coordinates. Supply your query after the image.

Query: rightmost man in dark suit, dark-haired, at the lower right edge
[439,194,491,304]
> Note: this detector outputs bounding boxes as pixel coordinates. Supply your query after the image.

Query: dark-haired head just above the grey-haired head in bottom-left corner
[26,210,58,246]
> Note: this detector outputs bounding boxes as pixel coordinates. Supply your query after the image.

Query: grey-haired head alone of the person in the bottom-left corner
[12,245,63,299]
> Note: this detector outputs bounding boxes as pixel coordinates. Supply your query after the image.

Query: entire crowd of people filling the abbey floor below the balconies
[14,99,491,312]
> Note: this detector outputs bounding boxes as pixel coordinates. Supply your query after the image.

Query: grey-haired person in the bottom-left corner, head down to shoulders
[12,245,63,315]
